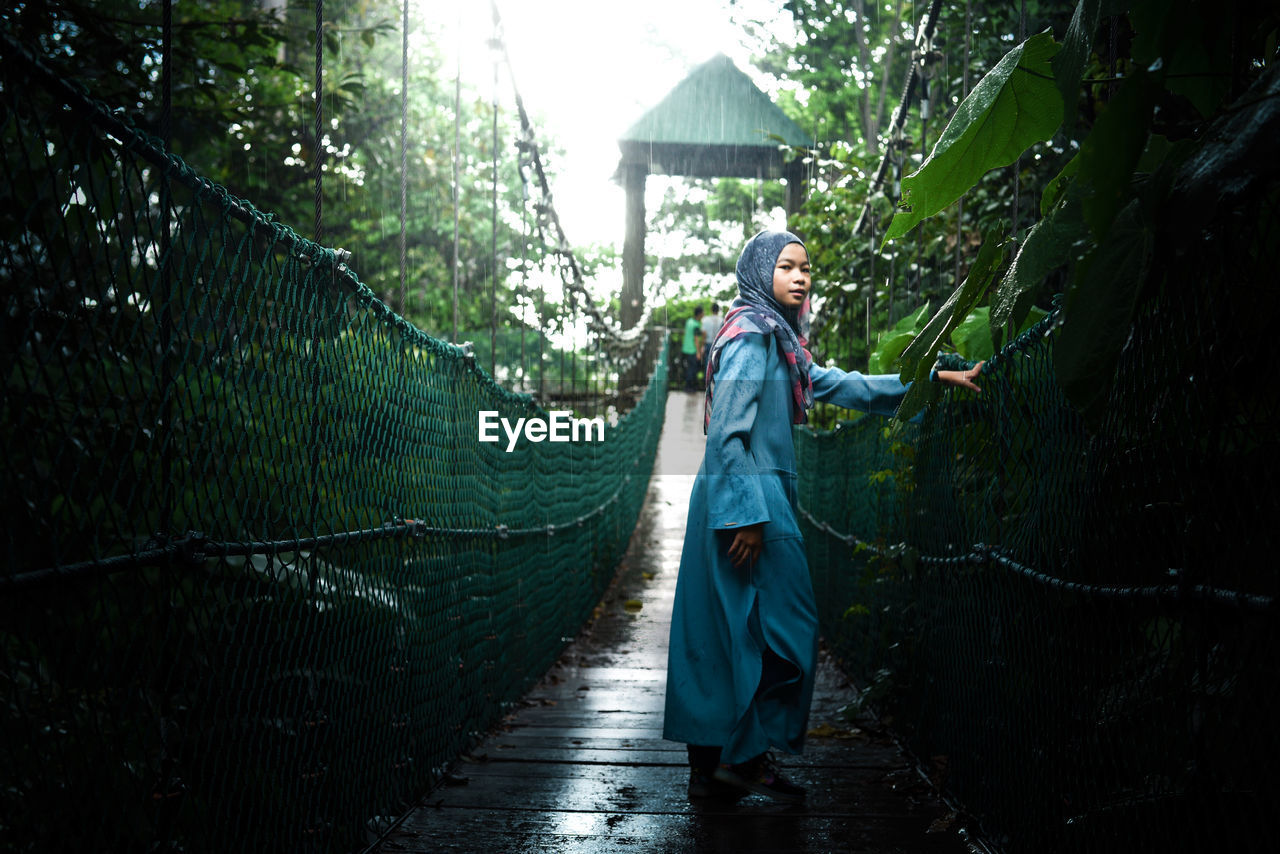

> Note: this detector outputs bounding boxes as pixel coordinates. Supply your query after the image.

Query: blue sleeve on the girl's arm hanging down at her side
[703,334,769,529]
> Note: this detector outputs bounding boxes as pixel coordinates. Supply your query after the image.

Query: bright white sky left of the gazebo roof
[435,0,790,251]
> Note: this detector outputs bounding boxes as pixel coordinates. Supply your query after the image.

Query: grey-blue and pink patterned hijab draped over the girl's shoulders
[703,232,813,433]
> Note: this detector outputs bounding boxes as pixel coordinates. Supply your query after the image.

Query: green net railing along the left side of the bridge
[0,36,666,853]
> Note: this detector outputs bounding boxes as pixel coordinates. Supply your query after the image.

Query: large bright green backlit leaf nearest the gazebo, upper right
[884,32,1062,242]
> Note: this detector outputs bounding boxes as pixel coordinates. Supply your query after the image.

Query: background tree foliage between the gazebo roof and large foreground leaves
[742,0,1074,370]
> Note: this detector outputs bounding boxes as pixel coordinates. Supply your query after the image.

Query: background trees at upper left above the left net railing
[0,0,560,348]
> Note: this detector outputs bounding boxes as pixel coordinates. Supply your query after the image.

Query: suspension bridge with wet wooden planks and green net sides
[0,4,1280,853]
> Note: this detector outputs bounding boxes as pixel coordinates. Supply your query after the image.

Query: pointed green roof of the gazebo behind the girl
[618,54,813,178]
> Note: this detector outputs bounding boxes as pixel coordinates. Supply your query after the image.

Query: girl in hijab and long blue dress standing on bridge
[663,230,982,803]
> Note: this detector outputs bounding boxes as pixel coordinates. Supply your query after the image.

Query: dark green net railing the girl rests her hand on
[797,285,1280,853]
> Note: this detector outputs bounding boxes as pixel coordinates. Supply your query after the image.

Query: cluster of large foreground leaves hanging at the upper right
[829,0,1277,417]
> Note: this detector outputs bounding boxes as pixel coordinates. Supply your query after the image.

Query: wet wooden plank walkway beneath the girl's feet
[375,392,983,854]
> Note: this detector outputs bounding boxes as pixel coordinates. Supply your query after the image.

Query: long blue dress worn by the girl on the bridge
[663,333,906,763]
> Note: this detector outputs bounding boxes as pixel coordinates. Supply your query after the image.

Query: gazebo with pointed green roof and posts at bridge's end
[614,54,814,325]
